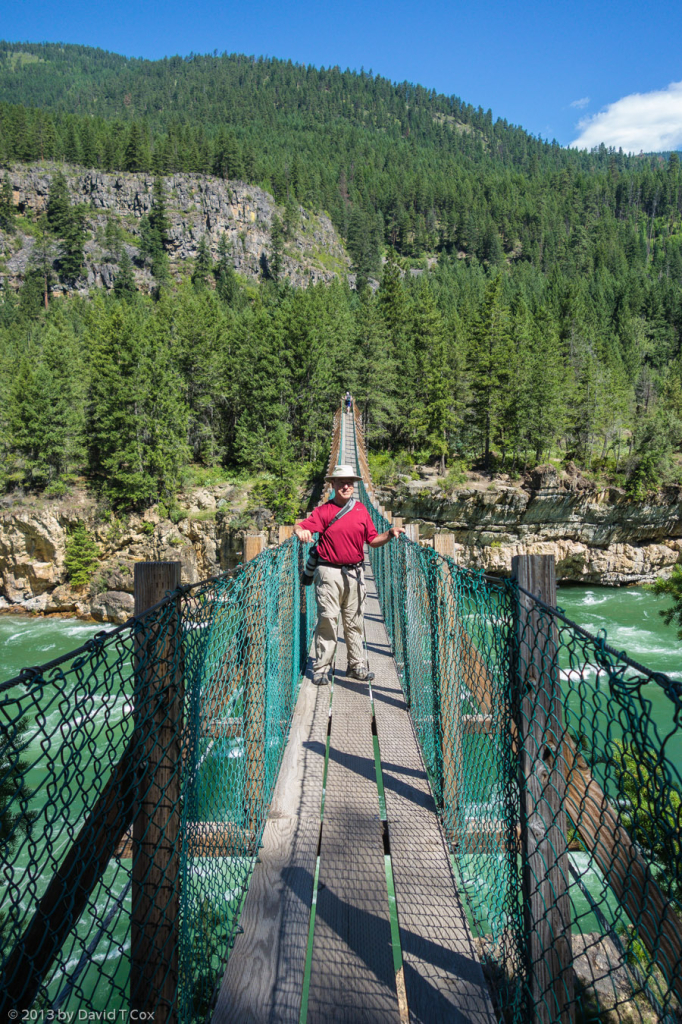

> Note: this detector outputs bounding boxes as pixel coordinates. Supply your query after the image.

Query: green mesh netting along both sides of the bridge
[0,403,682,1024]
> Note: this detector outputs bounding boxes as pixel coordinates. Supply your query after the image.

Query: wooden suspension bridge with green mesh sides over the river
[0,410,682,1024]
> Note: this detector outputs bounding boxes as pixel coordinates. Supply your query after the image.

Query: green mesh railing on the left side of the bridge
[0,539,314,1022]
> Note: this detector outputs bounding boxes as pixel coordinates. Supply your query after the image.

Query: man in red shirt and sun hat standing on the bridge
[294,466,404,686]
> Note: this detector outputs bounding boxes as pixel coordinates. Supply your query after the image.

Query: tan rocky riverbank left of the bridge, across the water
[0,484,276,624]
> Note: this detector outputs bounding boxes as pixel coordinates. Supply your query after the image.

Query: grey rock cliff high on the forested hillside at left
[0,164,349,294]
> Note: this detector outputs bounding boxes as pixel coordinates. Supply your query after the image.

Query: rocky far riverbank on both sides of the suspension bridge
[0,467,682,623]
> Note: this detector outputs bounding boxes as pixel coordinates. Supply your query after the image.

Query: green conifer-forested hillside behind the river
[0,43,682,516]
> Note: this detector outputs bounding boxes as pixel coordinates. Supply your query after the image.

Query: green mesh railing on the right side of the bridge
[356,411,682,1024]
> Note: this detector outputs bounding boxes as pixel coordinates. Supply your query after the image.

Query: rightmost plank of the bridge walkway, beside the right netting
[366,574,496,1024]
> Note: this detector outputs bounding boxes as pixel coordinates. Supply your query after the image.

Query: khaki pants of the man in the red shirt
[314,565,366,673]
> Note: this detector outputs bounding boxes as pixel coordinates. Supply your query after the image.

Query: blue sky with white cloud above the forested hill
[5,0,682,152]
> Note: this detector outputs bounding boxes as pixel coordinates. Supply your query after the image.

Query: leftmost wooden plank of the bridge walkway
[213,666,329,1024]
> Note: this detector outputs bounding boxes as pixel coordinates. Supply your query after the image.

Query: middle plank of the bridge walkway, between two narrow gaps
[307,641,400,1024]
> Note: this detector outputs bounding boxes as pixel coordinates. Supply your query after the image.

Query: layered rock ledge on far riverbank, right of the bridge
[379,466,682,586]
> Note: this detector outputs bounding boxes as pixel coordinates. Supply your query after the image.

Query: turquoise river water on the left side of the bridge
[0,615,252,1020]
